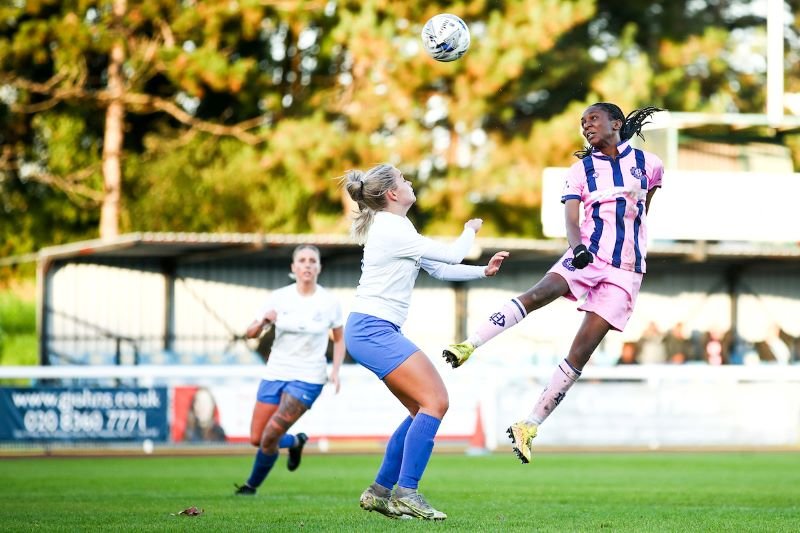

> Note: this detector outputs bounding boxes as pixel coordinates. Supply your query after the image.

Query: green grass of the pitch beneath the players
[0,453,800,533]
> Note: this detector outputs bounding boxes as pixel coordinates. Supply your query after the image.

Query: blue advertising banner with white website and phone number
[0,387,169,441]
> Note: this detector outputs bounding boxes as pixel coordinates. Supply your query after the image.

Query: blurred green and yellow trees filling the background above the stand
[0,0,800,258]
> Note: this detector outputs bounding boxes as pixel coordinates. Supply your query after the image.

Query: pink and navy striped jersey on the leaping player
[561,141,664,272]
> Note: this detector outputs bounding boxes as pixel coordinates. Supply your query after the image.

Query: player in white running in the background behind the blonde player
[236,244,344,495]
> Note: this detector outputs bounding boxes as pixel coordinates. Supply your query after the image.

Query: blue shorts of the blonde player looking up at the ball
[344,313,419,379]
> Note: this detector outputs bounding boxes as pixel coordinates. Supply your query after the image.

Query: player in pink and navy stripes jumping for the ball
[443,102,664,463]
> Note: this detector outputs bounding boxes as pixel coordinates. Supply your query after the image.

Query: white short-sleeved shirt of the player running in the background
[256,283,342,384]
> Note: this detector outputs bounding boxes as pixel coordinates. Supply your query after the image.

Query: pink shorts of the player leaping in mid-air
[548,250,643,331]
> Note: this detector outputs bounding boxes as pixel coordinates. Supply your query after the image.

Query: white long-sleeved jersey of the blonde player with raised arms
[351,211,485,326]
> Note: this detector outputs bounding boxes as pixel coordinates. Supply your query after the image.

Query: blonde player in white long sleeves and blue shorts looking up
[343,164,508,520]
